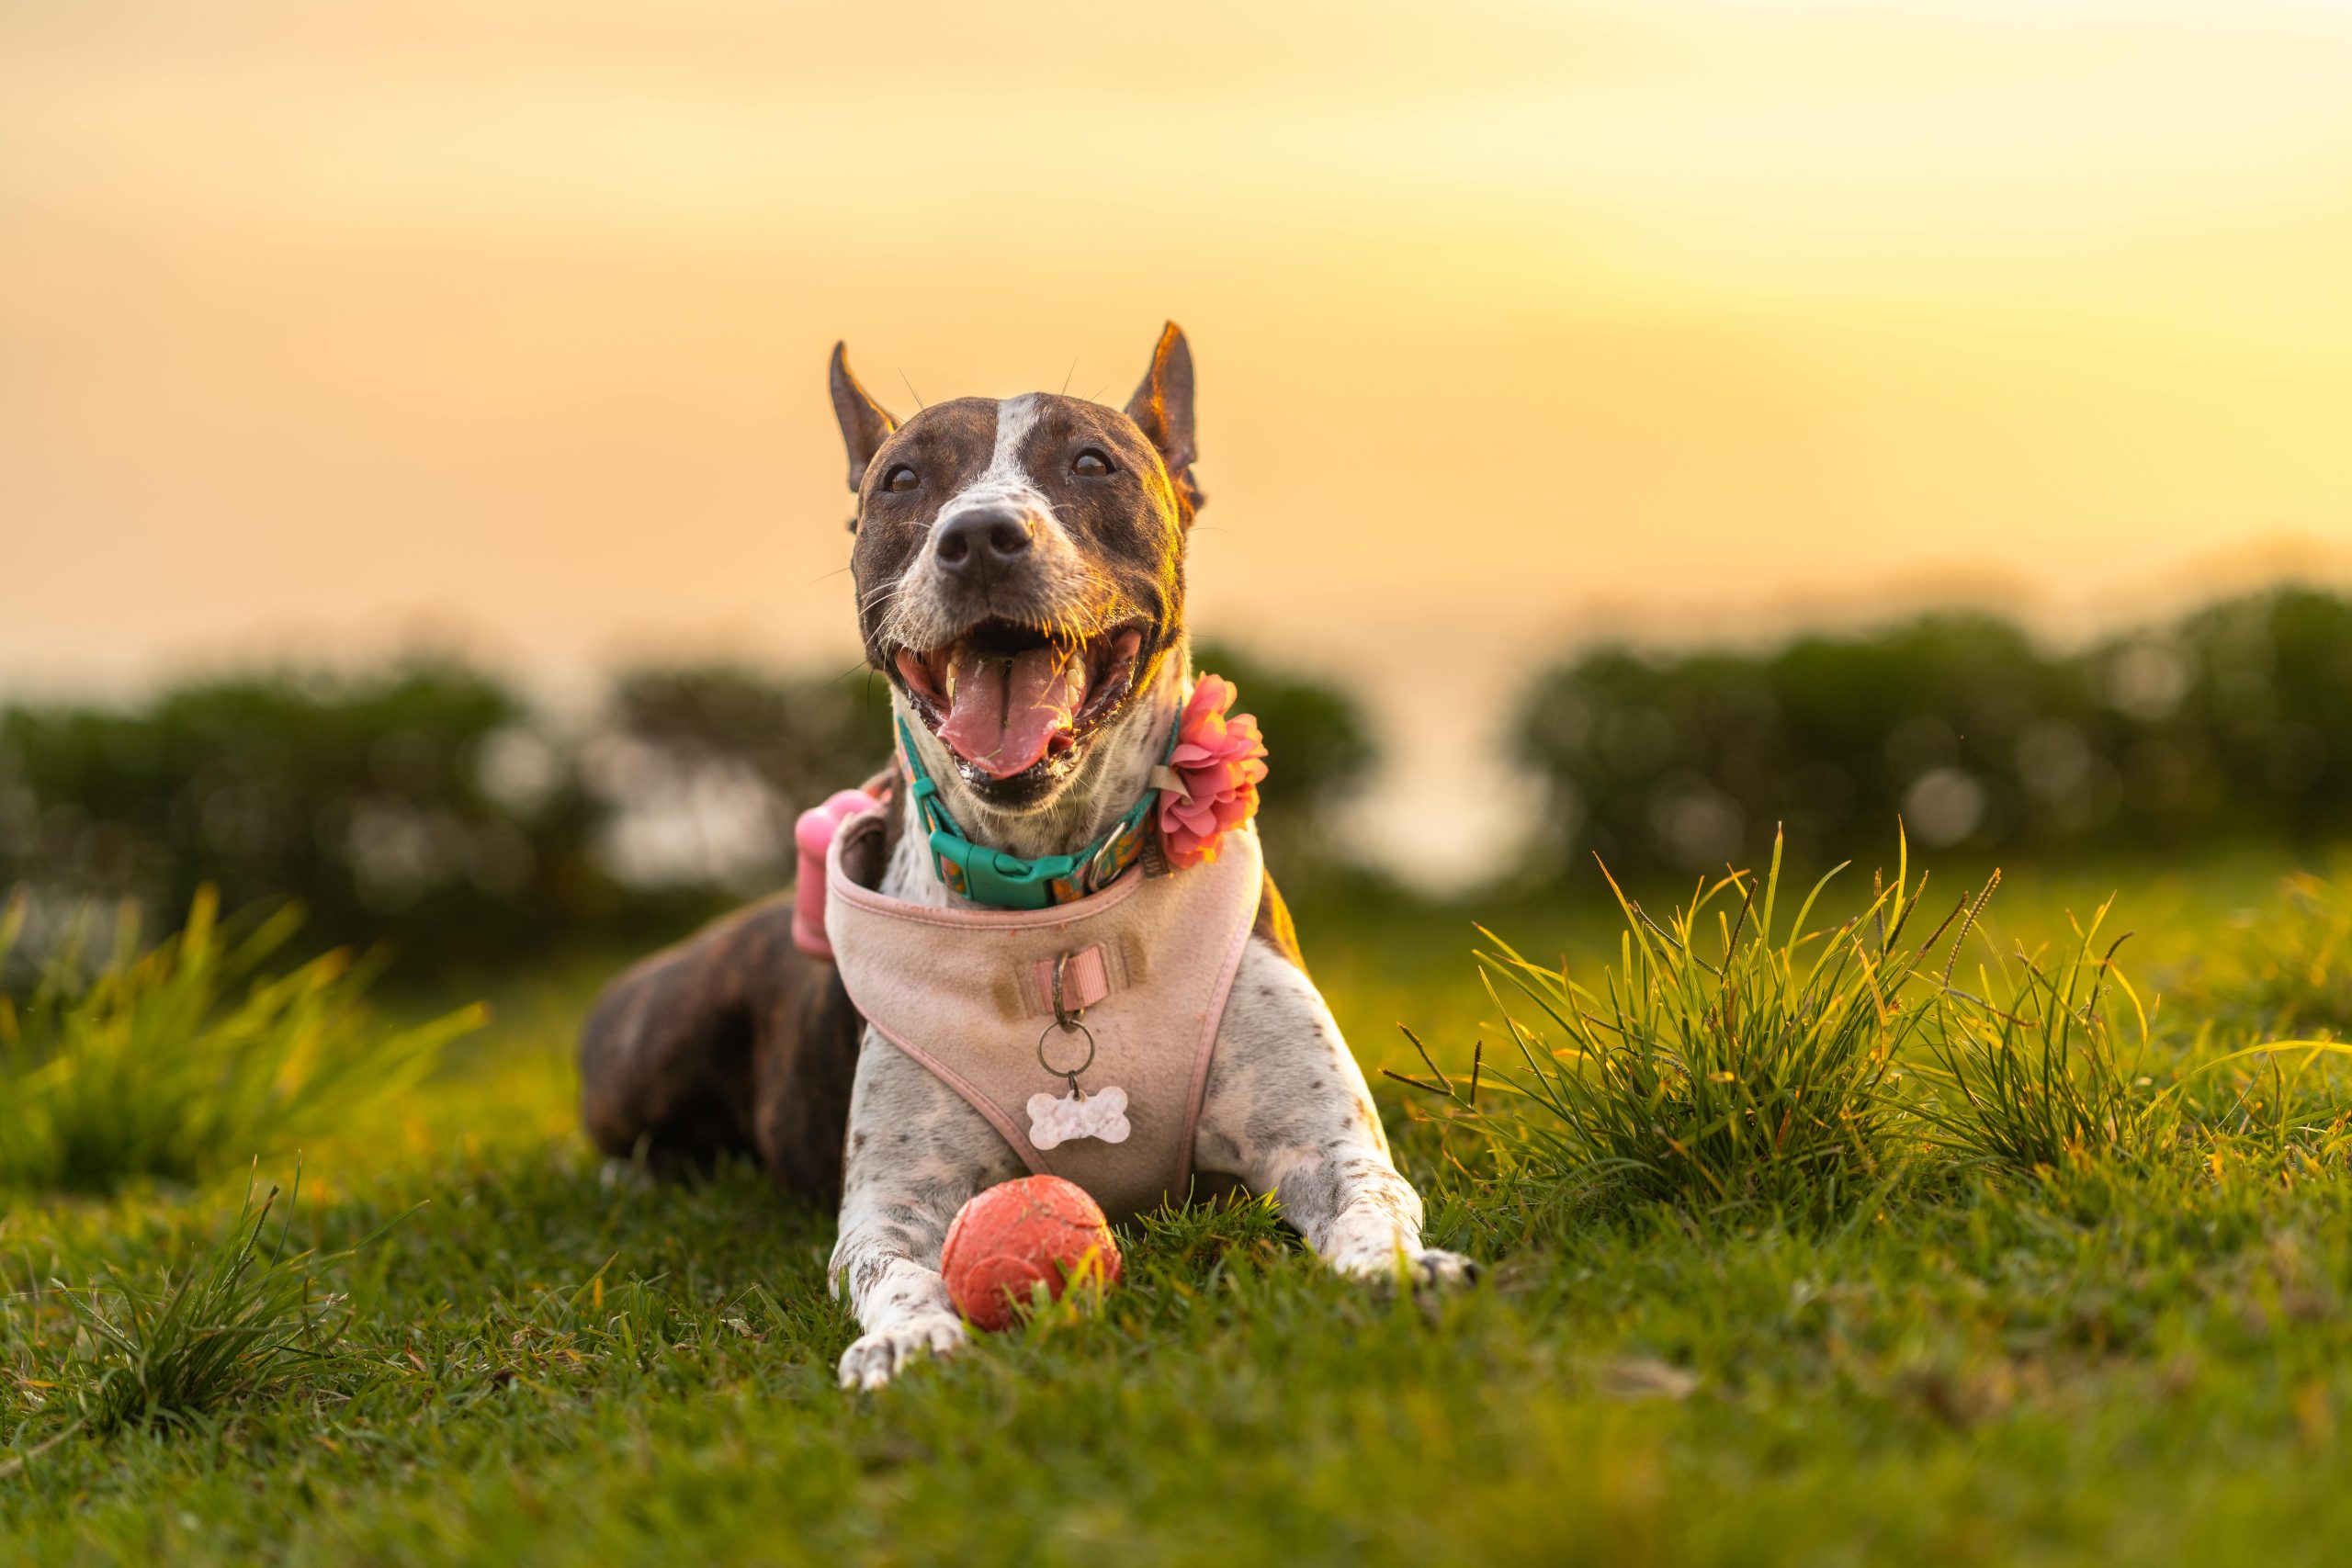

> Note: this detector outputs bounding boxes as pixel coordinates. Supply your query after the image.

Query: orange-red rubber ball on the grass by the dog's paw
[938,1176,1122,1331]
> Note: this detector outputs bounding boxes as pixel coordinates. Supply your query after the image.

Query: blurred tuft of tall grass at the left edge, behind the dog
[0,888,482,1194]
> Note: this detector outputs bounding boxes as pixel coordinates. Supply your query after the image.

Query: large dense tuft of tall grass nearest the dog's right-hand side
[1458,841,1971,1215]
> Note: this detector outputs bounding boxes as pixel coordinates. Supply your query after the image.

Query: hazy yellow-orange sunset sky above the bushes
[0,0,2352,870]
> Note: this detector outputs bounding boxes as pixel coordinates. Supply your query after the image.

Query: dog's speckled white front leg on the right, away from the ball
[1194,941,1477,1286]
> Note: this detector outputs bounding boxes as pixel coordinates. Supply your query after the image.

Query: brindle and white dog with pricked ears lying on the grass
[581,322,1477,1389]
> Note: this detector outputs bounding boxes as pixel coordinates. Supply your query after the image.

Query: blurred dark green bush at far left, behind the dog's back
[0,660,621,964]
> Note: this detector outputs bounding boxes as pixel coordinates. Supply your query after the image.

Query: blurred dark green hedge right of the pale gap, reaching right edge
[1515,590,2352,874]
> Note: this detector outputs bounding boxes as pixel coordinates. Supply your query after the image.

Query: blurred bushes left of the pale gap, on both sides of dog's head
[0,649,1376,974]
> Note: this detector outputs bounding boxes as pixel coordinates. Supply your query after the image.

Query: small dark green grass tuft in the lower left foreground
[0,1173,404,1474]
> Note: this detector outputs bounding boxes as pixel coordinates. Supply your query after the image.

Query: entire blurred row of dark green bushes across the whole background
[0,590,2352,974]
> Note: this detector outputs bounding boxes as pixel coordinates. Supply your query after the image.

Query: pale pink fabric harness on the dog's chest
[823,807,1265,1218]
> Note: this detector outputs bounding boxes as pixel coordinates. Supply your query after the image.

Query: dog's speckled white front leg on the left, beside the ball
[828,1030,1023,1389]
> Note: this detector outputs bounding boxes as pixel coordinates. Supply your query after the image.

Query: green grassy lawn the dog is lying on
[0,856,2352,1565]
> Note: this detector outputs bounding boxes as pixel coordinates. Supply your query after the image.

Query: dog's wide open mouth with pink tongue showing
[894,621,1143,781]
